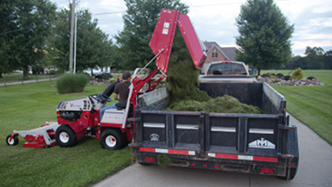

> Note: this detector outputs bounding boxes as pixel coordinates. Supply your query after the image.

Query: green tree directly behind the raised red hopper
[115,0,188,69]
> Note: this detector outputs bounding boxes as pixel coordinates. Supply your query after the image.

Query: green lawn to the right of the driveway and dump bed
[262,70,332,145]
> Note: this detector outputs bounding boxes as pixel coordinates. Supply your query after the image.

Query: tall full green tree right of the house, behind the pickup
[235,0,294,75]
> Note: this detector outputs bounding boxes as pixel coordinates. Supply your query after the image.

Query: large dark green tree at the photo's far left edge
[1,0,56,79]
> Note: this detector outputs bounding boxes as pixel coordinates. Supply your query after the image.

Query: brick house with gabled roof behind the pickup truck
[202,41,237,72]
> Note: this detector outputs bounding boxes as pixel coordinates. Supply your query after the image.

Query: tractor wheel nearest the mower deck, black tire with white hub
[55,125,77,147]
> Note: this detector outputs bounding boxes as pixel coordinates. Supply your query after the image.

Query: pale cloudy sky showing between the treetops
[50,0,332,55]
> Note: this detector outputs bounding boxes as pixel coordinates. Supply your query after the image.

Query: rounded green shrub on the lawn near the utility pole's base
[56,73,90,94]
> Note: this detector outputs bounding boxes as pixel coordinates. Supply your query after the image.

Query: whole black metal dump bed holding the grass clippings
[130,83,298,178]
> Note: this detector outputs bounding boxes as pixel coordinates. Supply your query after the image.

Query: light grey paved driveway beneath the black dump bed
[94,117,332,187]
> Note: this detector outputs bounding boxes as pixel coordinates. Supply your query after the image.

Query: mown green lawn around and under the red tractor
[0,81,131,186]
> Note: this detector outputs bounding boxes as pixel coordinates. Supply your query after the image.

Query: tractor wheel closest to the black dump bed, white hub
[100,129,127,150]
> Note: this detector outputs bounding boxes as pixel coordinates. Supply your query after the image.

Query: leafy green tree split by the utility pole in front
[48,9,114,73]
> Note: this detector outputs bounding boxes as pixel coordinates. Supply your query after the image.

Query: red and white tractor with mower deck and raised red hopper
[6,9,206,149]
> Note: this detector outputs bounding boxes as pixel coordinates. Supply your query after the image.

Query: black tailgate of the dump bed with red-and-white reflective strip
[135,110,283,162]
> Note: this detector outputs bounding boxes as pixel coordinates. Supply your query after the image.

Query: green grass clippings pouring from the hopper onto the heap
[166,30,262,114]
